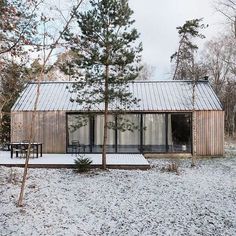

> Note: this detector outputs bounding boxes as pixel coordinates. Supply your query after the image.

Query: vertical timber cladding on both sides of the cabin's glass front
[11,111,224,156]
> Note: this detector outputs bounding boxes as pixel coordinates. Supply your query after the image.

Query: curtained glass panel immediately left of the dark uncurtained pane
[143,114,166,152]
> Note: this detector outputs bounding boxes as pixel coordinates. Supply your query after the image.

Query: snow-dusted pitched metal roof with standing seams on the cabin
[12,81,222,112]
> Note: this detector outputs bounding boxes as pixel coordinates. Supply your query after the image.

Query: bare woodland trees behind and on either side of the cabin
[0,0,236,146]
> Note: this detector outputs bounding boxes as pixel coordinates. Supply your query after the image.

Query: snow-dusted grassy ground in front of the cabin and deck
[0,154,236,236]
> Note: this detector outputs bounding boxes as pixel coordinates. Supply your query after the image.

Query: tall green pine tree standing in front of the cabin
[62,0,142,169]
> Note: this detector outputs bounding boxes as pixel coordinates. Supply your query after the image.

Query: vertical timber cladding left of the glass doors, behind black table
[11,111,66,153]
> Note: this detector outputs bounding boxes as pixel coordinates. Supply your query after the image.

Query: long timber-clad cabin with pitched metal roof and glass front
[11,81,224,156]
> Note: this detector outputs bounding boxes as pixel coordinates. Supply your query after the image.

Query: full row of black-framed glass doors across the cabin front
[67,113,192,153]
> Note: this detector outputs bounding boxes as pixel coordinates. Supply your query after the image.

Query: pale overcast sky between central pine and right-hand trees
[130,0,223,80]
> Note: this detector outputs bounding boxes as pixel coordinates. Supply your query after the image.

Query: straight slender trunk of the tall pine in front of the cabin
[102,65,109,170]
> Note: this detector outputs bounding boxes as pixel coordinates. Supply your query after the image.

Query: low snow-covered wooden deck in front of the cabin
[0,151,150,170]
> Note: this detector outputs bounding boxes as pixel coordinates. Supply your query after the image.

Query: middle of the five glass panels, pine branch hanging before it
[117,114,141,152]
